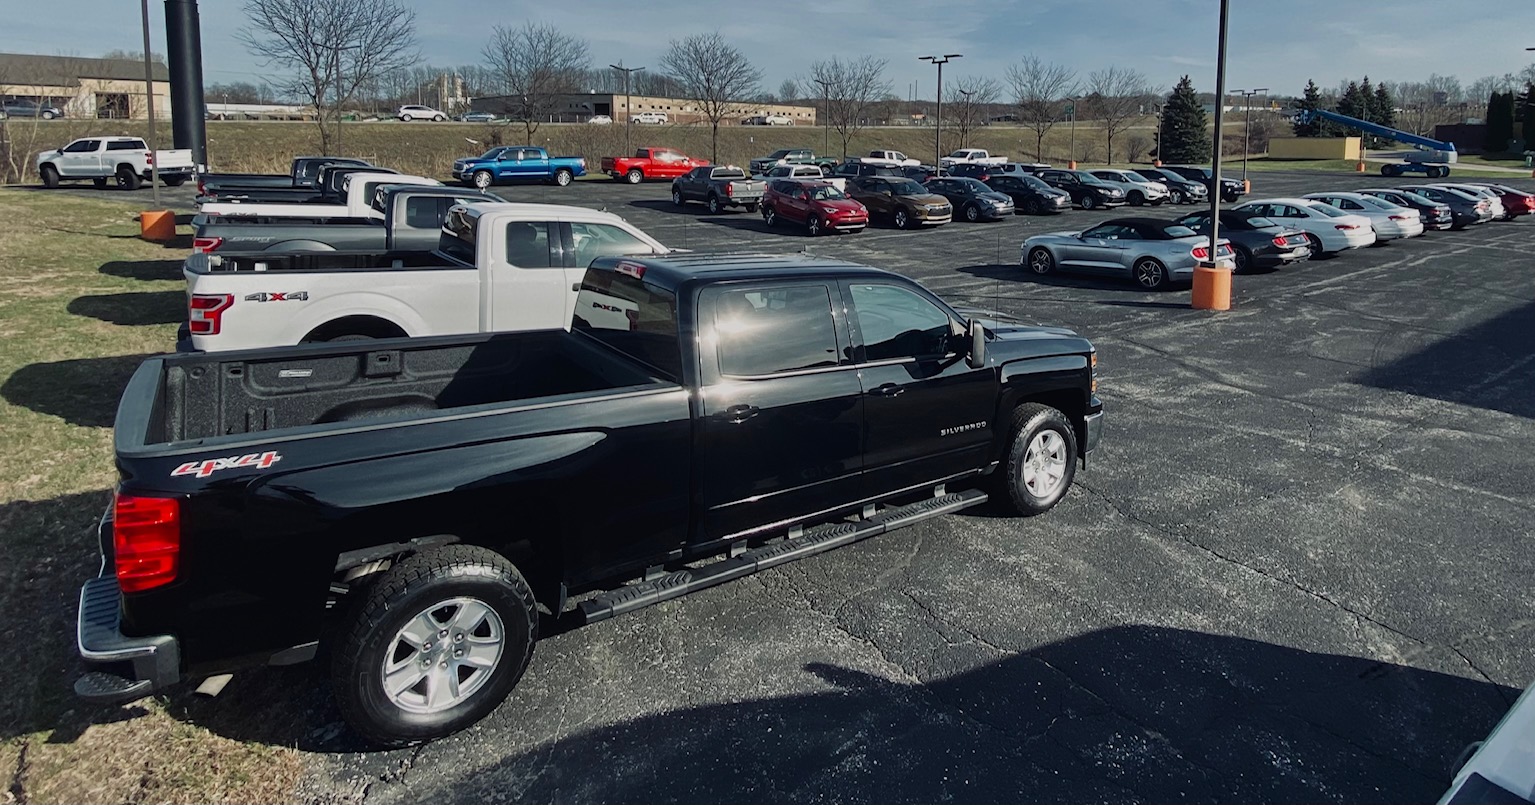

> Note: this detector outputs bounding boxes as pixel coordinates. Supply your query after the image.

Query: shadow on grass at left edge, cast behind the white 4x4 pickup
[0,355,152,427]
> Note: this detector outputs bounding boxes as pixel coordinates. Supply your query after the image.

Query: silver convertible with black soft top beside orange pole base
[1018,218,1233,290]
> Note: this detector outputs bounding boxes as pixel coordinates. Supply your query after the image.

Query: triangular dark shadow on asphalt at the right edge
[1358,303,1535,418]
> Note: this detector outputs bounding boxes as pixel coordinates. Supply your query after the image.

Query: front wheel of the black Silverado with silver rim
[995,403,1076,516]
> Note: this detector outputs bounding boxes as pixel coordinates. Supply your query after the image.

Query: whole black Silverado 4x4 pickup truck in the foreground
[75,255,1104,745]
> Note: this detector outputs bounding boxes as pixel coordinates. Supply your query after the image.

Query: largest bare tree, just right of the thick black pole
[238,0,419,154]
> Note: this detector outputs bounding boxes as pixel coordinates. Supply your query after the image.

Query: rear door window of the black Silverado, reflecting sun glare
[714,283,838,376]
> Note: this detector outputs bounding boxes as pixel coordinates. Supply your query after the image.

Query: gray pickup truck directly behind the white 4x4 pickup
[192,184,500,253]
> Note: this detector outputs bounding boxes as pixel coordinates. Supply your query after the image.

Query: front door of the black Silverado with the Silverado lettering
[843,280,1005,495]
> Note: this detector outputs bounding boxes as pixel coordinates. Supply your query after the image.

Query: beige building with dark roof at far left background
[0,54,170,120]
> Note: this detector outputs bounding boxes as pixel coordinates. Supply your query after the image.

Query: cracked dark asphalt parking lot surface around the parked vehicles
[62,172,1535,802]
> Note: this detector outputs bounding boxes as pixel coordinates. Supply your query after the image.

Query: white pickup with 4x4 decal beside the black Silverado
[178,203,669,352]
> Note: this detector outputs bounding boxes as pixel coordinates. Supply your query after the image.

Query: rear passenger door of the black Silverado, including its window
[695,281,863,542]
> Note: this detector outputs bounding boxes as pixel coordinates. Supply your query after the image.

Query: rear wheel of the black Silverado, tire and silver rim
[332,545,539,747]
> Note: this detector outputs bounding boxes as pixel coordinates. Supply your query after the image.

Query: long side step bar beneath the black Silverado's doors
[577,490,987,624]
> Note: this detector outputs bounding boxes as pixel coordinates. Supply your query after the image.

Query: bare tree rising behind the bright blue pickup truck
[482,22,591,143]
